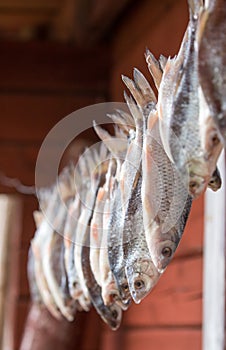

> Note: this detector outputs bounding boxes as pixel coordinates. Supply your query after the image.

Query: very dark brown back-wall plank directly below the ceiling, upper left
[0,41,111,92]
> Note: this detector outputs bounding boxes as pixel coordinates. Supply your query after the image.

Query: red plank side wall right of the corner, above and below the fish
[100,0,203,350]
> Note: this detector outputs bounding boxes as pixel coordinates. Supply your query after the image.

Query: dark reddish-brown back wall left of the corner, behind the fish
[0,42,109,350]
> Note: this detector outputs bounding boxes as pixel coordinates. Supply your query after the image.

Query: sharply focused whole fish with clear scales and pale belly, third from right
[142,111,192,272]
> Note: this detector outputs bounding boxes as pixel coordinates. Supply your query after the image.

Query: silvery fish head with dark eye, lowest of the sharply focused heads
[126,258,160,304]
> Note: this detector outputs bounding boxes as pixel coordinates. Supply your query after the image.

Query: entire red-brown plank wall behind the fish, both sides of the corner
[0,0,203,350]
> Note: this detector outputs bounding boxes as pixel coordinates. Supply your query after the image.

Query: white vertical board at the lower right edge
[203,154,226,350]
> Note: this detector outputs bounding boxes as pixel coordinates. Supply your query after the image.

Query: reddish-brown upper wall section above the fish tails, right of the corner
[110,0,188,101]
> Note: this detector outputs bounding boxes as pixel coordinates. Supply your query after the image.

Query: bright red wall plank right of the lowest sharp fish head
[123,257,202,327]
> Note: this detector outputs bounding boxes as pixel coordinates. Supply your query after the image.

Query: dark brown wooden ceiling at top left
[0,0,133,45]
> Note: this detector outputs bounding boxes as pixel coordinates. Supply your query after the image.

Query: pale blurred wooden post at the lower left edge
[0,195,22,350]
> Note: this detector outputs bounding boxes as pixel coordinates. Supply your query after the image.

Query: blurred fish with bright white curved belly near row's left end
[42,167,75,321]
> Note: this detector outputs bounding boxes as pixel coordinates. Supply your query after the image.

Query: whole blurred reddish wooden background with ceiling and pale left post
[0,0,203,350]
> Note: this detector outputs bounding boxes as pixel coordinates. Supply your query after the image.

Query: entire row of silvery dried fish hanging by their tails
[28,0,226,329]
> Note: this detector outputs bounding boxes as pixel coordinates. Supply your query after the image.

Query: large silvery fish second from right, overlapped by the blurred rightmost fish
[158,0,219,197]
